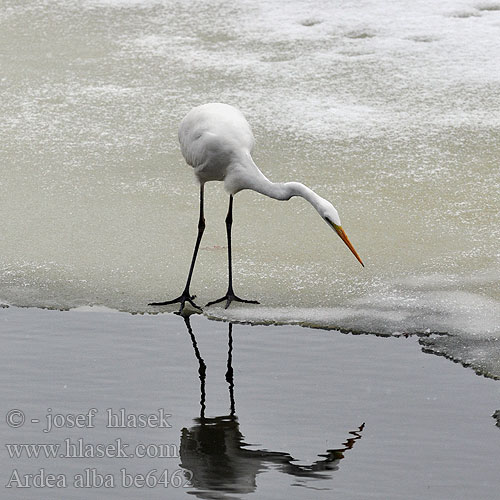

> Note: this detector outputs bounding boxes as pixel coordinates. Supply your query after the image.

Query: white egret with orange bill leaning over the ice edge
[149,103,364,312]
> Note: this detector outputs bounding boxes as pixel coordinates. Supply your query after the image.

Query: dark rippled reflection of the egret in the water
[180,317,365,499]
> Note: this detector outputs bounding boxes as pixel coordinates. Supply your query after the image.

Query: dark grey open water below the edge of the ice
[0,308,500,500]
